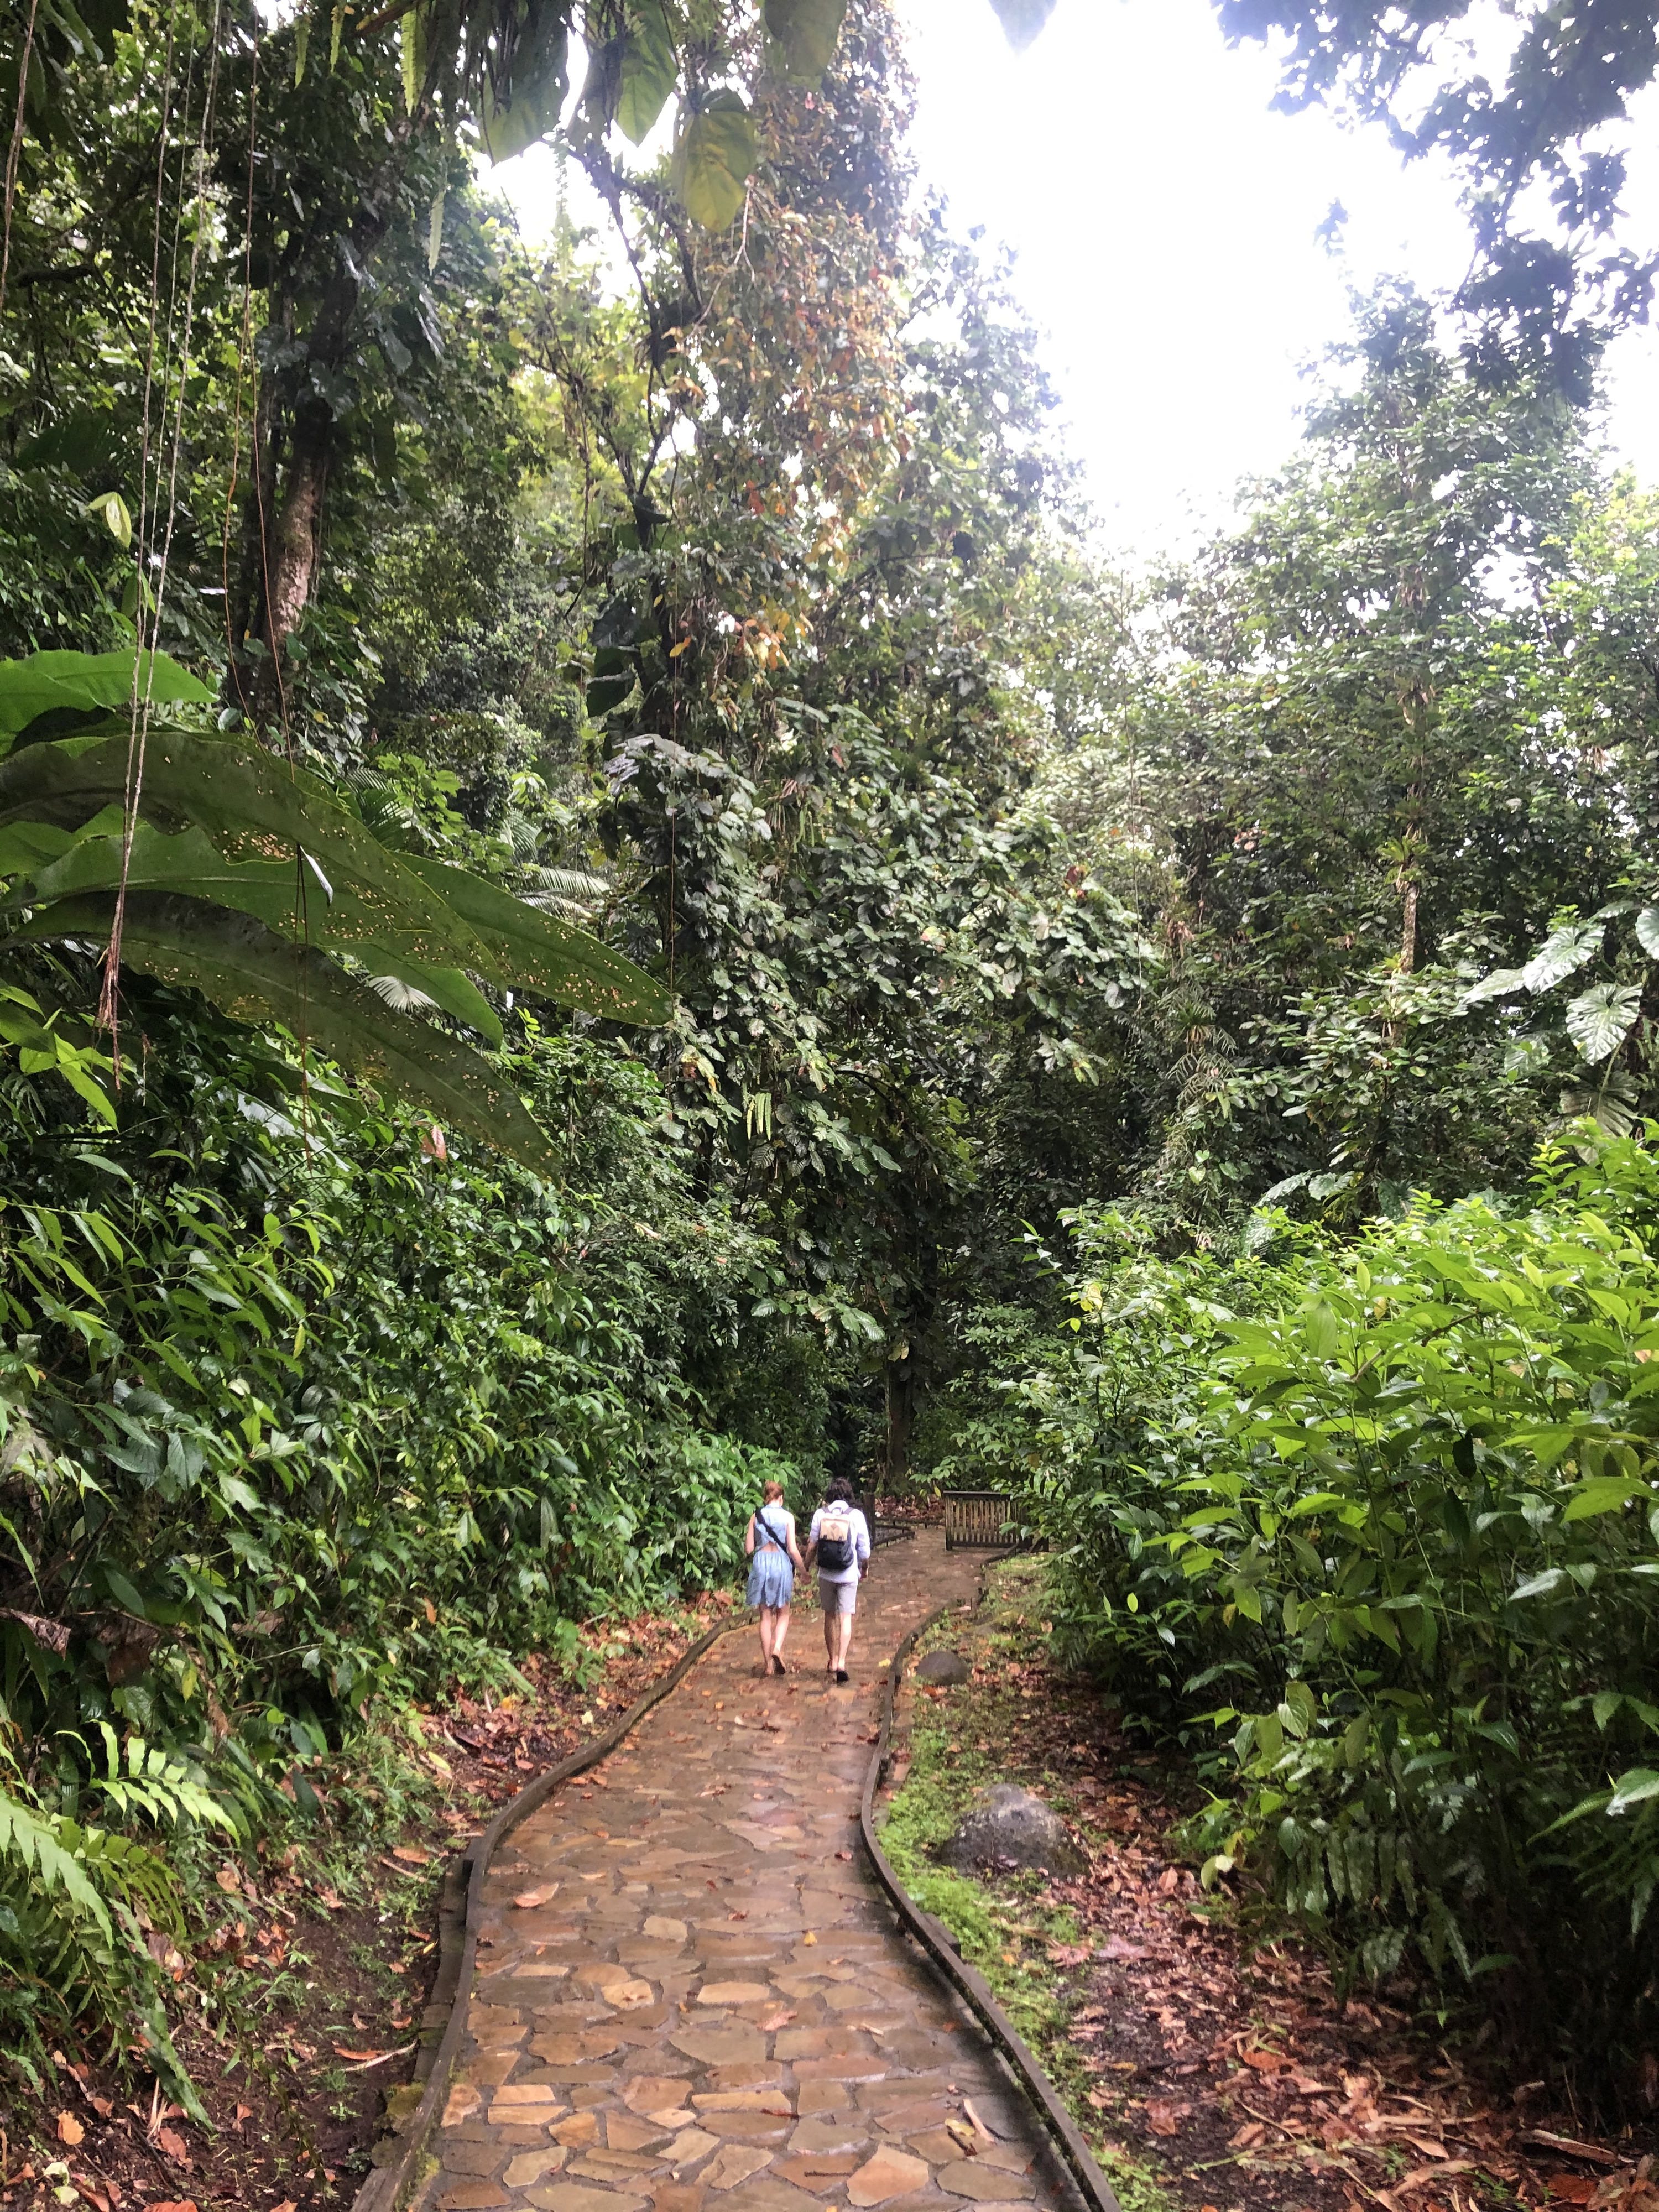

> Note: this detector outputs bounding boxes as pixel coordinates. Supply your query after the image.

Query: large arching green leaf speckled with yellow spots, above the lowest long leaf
[0,730,491,973]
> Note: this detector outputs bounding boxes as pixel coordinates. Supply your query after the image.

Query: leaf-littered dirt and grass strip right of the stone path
[894,1559,1659,2212]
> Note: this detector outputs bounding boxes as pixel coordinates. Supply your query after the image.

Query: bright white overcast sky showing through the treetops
[495,0,1659,555]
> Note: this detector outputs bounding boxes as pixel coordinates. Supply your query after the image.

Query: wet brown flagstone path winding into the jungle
[425,1531,1075,2212]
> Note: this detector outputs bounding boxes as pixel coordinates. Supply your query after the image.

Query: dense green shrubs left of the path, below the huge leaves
[0,969,801,2070]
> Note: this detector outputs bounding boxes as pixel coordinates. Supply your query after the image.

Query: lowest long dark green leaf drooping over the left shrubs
[22,891,553,1172]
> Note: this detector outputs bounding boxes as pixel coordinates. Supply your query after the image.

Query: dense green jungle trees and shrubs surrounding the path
[0,0,1659,2110]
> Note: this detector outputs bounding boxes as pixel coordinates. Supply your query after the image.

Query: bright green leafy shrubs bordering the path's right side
[1020,1124,1659,2101]
